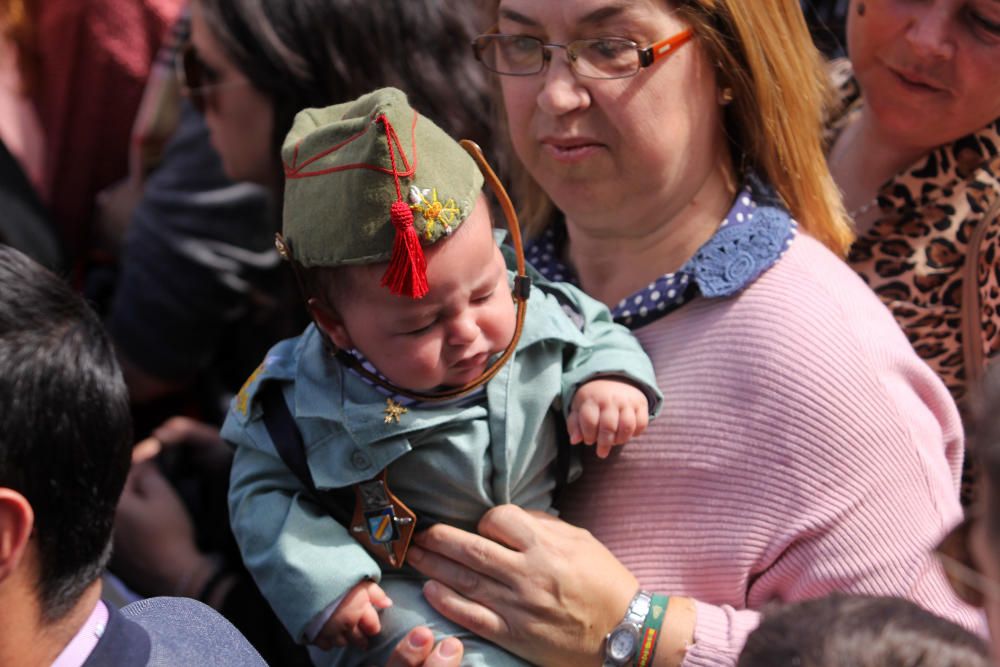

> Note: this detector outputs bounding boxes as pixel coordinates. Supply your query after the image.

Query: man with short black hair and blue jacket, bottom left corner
[0,246,265,667]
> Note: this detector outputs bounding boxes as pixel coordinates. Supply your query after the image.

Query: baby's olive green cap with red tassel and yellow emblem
[278,88,483,298]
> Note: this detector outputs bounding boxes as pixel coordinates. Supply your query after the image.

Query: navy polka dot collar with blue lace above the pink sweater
[525,175,798,329]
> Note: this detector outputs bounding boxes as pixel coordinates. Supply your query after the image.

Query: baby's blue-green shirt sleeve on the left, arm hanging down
[223,402,380,642]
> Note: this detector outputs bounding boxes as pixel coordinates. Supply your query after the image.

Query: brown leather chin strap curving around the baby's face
[276,139,531,401]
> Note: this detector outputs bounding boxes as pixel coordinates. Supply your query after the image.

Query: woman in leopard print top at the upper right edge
[827,0,1000,418]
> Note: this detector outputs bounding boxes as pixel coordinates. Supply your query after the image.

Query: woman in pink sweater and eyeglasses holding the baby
[394,0,983,667]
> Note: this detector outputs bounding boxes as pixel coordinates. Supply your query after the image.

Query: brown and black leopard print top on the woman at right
[825,60,1000,414]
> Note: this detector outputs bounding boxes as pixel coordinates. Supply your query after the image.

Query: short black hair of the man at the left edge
[0,245,132,620]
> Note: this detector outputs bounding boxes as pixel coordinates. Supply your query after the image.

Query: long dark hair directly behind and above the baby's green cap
[198,0,491,183]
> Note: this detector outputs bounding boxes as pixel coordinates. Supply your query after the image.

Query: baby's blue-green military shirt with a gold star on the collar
[222,268,662,640]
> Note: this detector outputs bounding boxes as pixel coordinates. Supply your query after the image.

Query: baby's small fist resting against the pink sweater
[566,379,649,459]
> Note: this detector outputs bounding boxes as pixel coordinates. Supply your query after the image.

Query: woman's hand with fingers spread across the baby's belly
[407,505,639,667]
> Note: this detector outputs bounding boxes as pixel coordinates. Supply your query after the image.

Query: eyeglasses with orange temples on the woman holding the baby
[472,28,694,79]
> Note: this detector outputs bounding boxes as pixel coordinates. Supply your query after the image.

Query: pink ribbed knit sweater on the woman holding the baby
[560,235,985,667]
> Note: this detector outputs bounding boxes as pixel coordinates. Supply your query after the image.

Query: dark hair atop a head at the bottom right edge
[737,593,991,667]
